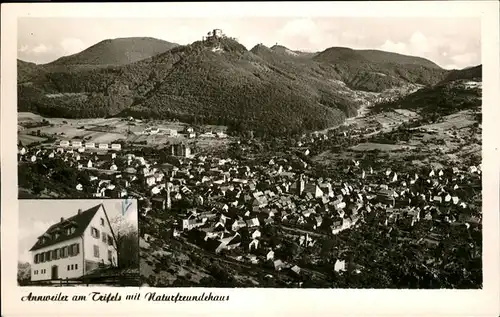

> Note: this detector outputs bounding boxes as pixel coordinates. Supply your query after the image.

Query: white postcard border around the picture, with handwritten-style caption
[1,1,500,316]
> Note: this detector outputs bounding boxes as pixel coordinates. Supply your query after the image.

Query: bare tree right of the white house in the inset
[111,215,139,269]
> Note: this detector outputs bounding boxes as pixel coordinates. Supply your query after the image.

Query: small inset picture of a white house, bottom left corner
[17,199,139,286]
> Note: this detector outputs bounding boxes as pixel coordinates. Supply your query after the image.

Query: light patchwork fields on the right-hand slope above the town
[312,109,481,166]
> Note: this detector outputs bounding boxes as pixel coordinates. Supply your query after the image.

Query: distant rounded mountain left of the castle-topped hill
[47,37,178,66]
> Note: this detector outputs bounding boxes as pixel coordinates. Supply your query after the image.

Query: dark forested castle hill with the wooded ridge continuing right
[18,34,454,134]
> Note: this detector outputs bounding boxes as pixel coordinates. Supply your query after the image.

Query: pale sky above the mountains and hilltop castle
[17,17,481,68]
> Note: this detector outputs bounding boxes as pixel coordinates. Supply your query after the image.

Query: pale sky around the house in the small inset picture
[18,199,138,263]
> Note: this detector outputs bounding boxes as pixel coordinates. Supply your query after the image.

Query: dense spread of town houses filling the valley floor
[20,121,481,274]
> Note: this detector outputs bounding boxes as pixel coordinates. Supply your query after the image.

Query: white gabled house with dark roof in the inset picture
[30,204,118,281]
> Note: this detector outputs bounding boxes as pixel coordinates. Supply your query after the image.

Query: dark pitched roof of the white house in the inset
[30,204,102,251]
